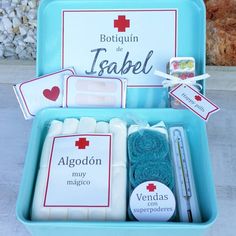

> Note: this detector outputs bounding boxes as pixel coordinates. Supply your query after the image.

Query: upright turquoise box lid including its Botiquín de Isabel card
[37,0,205,107]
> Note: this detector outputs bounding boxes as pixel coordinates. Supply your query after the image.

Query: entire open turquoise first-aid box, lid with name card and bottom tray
[16,0,217,236]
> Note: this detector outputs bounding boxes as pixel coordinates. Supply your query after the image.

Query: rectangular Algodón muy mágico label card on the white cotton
[44,134,112,207]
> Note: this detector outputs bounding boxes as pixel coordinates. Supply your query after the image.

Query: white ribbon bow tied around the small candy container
[154,70,210,90]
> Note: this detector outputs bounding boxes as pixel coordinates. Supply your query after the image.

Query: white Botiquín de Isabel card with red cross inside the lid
[62,9,177,87]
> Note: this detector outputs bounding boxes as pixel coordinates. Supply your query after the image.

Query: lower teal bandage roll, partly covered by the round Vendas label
[129,160,174,190]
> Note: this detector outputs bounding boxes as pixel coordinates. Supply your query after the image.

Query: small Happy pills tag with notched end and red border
[169,84,220,121]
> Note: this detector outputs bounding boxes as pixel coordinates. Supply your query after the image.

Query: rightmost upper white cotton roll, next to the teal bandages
[109,118,127,166]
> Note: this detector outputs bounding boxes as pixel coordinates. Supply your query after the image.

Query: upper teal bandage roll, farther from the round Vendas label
[128,129,169,163]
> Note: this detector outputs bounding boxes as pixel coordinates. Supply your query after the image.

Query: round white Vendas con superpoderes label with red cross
[130,181,176,221]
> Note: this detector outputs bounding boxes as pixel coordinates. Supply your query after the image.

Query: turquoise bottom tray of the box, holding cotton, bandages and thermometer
[17,109,216,235]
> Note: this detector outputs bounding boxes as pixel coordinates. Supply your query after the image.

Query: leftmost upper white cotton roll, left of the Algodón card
[40,120,63,168]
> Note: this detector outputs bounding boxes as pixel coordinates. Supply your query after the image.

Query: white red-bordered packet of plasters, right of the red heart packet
[63,75,127,108]
